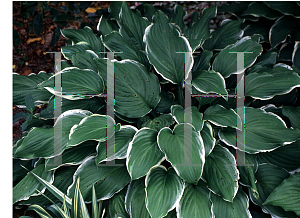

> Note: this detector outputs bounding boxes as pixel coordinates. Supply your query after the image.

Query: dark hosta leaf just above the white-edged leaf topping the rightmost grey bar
[202,20,244,50]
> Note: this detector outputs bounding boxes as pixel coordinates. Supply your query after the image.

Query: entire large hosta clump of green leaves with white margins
[13,2,300,218]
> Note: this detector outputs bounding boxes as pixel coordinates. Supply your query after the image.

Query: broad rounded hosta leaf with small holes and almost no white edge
[97,59,160,118]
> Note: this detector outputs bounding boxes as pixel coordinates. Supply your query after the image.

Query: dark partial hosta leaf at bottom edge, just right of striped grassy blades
[107,188,129,218]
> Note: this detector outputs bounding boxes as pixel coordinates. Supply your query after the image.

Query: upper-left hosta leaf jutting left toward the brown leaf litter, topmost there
[61,26,104,54]
